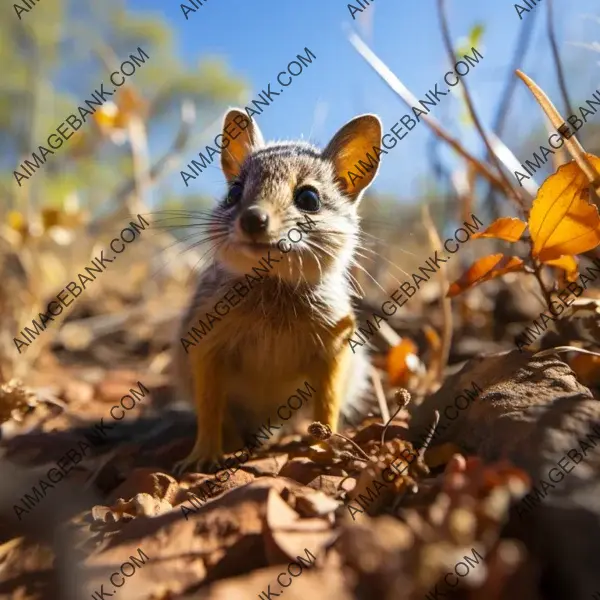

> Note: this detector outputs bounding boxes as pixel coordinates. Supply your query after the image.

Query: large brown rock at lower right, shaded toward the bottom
[410,350,600,600]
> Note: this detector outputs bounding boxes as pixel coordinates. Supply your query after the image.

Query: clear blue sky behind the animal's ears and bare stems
[128,0,600,203]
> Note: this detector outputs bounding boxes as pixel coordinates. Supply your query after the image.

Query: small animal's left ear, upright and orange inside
[221,108,264,181]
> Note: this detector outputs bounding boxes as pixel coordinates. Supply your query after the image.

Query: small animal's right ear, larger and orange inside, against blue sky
[322,115,381,200]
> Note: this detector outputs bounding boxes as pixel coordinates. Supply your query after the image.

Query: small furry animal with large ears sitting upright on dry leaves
[174,109,381,472]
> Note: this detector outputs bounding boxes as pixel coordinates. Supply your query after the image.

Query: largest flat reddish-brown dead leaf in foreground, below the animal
[85,473,295,600]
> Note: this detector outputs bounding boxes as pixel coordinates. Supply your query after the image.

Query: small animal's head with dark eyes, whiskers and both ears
[211,109,381,284]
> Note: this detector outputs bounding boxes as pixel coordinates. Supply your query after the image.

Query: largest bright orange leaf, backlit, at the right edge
[529,154,600,262]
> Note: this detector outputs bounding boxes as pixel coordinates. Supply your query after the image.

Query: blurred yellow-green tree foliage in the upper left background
[0,0,246,213]
